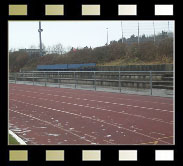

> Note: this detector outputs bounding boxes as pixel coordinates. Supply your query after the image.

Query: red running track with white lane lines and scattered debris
[9,84,174,145]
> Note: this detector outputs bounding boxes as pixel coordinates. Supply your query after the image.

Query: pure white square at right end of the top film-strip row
[155,5,173,16]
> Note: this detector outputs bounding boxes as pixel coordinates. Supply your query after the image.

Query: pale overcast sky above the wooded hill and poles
[9,20,174,50]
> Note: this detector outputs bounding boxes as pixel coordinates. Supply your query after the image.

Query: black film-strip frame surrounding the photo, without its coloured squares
[0,0,180,166]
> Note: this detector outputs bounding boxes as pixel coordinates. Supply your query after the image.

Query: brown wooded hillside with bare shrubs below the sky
[9,32,173,72]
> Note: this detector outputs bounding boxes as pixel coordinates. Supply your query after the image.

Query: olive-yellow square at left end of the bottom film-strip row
[9,150,28,161]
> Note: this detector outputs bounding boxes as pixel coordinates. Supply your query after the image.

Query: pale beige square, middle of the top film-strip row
[82,5,100,16]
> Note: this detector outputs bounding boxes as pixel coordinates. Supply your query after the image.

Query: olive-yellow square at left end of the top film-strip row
[9,5,27,16]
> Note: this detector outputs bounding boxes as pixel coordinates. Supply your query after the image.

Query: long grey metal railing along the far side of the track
[9,71,174,95]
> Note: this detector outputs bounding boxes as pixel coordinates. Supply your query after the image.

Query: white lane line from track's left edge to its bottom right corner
[10,99,170,144]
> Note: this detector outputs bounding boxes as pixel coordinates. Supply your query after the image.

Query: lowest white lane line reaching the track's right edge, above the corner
[10,94,172,124]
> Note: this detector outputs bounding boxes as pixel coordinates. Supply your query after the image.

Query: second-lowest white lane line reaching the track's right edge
[9,90,173,113]
